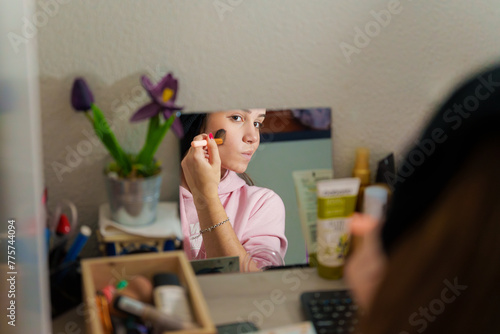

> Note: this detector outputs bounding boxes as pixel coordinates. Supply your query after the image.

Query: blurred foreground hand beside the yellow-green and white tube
[345,213,387,311]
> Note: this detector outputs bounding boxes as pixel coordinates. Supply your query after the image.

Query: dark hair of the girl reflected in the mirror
[179,113,255,186]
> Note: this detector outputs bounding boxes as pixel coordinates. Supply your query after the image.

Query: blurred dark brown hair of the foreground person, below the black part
[359,134,500,334]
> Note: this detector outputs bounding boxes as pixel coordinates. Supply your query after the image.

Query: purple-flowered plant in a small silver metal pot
[71,73,183,226]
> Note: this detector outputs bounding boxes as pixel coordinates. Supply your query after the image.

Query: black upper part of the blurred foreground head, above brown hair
[382,67,500,254]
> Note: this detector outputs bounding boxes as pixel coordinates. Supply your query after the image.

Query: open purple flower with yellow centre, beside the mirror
[130,73,184,138]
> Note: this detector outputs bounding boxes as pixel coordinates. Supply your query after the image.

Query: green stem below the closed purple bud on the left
[92,104,132,176]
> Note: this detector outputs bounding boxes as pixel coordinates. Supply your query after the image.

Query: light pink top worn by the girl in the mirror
[179,171,288,260]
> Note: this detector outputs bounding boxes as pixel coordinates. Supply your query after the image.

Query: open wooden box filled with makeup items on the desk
[82,251,217,334]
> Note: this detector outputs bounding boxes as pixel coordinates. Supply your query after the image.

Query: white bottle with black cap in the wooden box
[153,273,193,323]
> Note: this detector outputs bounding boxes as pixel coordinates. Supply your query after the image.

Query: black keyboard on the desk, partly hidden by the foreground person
[300,290,358,334]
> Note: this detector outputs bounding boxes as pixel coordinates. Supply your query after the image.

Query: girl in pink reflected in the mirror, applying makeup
[179,109,287,264]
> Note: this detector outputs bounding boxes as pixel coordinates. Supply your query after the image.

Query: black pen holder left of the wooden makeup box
[50,259,82,319]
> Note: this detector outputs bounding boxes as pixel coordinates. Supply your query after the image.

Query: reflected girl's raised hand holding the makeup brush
[181,133,221,203]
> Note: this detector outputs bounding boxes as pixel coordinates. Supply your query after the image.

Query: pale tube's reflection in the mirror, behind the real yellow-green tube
[292,169,333,267]
